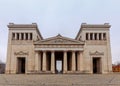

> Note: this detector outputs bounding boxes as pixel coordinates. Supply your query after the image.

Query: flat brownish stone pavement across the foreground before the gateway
[0,74,120,86]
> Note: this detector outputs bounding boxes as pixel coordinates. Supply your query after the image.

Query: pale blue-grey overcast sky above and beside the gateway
[0,0,120,62]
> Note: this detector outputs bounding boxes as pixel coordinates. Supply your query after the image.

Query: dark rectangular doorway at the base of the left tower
[18,57,25,73]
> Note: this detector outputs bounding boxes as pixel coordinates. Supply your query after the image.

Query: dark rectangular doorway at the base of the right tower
[93,58,100,74]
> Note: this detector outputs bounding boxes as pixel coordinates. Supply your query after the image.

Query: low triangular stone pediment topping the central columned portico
[34,34,84,44]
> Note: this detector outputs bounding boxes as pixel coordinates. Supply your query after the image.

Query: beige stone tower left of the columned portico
[6,23,42,73]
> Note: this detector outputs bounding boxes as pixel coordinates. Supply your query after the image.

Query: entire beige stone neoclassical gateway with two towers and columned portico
[6,23,112,74]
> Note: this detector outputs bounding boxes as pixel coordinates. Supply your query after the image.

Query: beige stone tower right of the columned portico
[76,23,112,73]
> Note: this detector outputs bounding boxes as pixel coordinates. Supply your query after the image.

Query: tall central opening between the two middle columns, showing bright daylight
[55,52,63,74]
